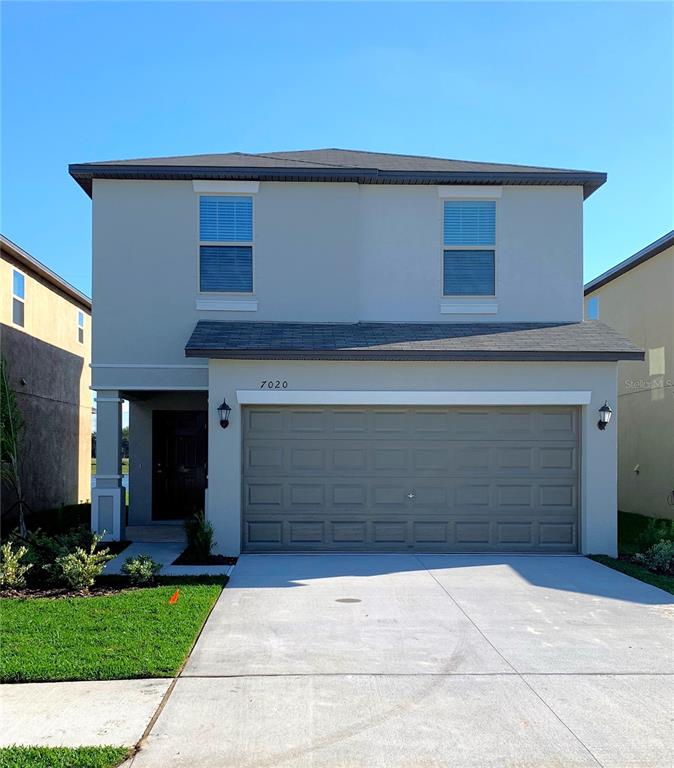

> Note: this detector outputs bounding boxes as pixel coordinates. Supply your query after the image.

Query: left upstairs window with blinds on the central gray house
[199,196,253,293]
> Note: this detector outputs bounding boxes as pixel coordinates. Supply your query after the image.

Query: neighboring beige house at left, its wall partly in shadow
[0,235,91,512]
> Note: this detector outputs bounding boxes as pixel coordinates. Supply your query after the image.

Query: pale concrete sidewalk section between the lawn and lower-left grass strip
[0,680,172,747]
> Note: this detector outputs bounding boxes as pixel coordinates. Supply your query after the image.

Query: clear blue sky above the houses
[0,2,674,292]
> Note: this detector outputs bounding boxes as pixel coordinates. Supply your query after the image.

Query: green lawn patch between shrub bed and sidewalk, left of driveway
[0,577,225,682]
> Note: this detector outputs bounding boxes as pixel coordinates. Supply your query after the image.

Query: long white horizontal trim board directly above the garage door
[236,389,592,405]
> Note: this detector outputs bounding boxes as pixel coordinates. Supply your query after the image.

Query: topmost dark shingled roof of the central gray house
[69,149,606,197]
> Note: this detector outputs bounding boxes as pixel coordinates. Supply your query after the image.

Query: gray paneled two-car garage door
[243,406,579,552]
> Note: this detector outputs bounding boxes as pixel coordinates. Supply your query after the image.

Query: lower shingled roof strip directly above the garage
[185,320,644,361]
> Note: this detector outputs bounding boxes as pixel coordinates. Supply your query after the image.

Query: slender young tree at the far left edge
[0,359,26,536]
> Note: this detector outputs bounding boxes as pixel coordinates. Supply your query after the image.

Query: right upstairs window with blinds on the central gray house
[442,200,496,296]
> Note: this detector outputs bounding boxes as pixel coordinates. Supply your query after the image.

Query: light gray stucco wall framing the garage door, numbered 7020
[207,360,620,555]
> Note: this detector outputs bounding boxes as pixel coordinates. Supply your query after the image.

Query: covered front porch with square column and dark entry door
[91,390,208,547]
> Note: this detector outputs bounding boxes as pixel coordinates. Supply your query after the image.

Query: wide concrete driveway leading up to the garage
[133,555,674,768]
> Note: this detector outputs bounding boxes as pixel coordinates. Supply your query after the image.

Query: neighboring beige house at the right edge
[585,230,674,518]
